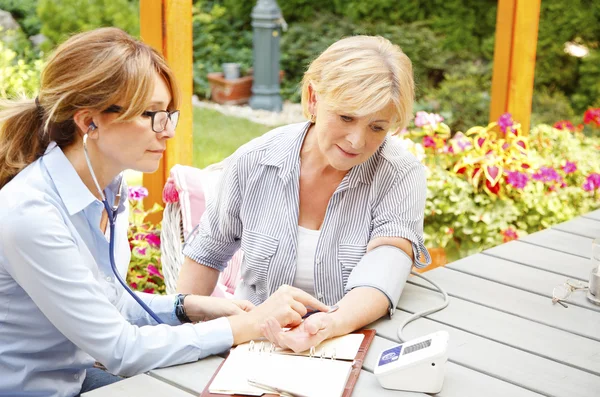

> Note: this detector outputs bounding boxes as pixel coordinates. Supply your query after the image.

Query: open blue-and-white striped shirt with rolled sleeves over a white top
[184,123,430,306]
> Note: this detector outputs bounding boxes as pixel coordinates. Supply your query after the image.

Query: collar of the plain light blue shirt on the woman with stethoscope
[42,142,127,215]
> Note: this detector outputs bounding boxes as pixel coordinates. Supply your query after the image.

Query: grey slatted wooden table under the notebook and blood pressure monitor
[85,211,600,397]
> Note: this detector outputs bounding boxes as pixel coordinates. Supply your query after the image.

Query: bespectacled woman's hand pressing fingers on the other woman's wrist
[229,285,329,345]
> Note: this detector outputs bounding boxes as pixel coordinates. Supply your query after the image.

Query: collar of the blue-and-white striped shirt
[261,122,388,189]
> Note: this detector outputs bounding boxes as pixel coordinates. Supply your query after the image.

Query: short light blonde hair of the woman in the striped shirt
[302,36,415,130]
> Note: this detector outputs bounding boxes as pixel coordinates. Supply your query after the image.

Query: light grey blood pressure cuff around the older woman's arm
[346,245,413,317]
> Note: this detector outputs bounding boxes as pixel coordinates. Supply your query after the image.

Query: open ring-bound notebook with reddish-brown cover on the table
[202,330,375,397]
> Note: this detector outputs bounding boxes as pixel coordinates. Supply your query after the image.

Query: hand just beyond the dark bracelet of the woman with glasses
[183,295,254,322]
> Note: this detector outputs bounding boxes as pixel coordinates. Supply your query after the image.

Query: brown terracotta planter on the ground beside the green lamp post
[207,70,283,105]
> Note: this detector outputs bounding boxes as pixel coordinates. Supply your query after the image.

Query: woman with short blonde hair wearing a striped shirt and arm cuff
[178,36,429,351]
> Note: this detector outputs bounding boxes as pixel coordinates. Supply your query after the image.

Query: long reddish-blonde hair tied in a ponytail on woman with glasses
[0,28,180,188]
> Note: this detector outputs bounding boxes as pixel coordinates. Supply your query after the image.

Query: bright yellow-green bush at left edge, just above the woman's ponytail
[0,37,42,98]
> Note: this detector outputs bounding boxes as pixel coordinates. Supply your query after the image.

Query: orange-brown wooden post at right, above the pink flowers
[490,0,541,134]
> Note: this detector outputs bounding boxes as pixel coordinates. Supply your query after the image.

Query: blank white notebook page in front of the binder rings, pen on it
[209,348,352,397]
